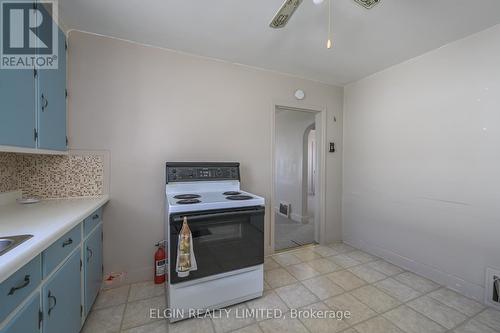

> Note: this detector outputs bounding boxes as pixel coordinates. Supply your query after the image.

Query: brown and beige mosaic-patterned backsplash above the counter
[0,152,104,199]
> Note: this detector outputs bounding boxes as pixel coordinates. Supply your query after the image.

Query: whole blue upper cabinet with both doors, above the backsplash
[0,4,67,151]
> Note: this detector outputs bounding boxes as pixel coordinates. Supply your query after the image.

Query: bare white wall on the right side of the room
[342,26,500,299]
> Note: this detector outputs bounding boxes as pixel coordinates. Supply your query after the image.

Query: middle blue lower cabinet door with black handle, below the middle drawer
[42,250,82,333]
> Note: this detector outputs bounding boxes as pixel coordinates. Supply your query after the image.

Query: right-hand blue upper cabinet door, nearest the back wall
[37,14,66,150]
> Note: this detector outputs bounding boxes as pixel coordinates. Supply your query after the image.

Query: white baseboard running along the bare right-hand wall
[343,239,484,304]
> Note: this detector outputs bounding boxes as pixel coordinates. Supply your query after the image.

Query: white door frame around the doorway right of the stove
[266,102,327,254]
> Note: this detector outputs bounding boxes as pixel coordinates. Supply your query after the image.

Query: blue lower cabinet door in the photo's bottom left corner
[0,292,40,333]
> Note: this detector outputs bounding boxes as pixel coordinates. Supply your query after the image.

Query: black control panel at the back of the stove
[167,162,240,183]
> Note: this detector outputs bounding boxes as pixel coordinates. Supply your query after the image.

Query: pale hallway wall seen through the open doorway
[275,110,315,222]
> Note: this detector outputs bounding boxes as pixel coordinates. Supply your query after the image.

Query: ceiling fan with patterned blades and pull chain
[269,0,380,48]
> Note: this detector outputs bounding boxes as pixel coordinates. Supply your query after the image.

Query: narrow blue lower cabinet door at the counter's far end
[83,224,102,315]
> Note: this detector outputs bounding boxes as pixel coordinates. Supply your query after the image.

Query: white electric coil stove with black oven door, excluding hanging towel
[165,162,265,321]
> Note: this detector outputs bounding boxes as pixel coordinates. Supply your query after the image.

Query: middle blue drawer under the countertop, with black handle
[42,224,82,278]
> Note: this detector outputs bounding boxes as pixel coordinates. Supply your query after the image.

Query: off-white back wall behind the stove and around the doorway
[68,31,343,281]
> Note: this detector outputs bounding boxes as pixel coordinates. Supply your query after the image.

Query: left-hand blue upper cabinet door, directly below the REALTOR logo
[0,69,36,148]
